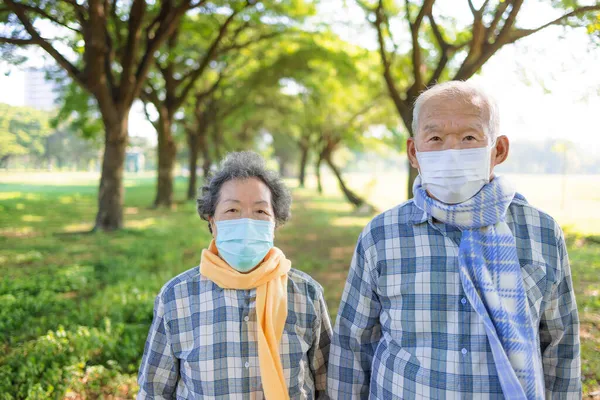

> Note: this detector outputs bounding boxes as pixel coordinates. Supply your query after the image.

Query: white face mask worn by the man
[417,143,495,204]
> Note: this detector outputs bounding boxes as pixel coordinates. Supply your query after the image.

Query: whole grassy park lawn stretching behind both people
[0,174,600,399]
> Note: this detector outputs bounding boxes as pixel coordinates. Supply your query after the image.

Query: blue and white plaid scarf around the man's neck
[413,177,544,400]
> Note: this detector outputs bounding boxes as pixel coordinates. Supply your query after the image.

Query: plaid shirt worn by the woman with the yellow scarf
[138,267,331,399]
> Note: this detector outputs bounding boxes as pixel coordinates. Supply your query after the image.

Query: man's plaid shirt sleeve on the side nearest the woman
[327,239,381,399]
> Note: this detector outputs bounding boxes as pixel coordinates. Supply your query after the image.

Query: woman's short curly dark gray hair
[196,151,292,232]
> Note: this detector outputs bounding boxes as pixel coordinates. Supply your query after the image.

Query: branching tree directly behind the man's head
[356,0,600,195]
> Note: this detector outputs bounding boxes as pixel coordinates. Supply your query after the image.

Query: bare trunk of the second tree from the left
[154,111,177,207]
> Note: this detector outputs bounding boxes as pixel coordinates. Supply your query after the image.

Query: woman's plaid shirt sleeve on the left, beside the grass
[137,293,179,399]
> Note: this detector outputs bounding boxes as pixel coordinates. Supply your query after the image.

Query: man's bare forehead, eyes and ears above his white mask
[407,96,509,176]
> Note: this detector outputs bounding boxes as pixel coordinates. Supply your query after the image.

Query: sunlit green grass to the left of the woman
[0,181,209,399]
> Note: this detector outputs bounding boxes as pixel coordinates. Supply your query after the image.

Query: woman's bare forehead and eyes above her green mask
[209,178,275,238]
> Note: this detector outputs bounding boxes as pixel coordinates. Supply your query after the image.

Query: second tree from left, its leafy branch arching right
[142,2,313,206]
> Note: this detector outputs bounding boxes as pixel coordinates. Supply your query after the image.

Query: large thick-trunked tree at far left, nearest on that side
[0,0,200,231]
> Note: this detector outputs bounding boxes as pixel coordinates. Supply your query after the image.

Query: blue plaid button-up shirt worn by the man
[327,195,581,399]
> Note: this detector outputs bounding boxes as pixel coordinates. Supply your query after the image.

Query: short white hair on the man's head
[412,81,500,140]
